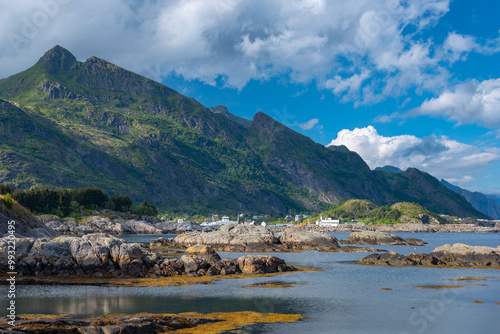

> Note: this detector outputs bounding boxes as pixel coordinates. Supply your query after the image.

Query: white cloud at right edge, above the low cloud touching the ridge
[409,79,500,128]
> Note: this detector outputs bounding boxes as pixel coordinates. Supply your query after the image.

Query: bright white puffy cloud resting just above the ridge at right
[329,125,500,180]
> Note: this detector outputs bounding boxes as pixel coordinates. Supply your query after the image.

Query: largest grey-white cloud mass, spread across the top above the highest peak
[0,0,456,103]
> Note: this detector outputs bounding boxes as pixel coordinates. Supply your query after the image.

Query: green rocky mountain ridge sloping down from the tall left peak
[0,46,485,217]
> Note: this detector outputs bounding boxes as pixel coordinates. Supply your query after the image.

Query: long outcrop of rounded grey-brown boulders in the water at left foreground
[0,234,295,278]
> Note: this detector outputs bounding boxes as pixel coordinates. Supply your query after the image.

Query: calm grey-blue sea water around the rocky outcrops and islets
[0,233,500,334]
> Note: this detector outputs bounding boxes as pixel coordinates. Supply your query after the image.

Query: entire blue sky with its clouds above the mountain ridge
[0,0,500,194]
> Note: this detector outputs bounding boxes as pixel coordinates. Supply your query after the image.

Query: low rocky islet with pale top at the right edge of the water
[358,244,500,269]
